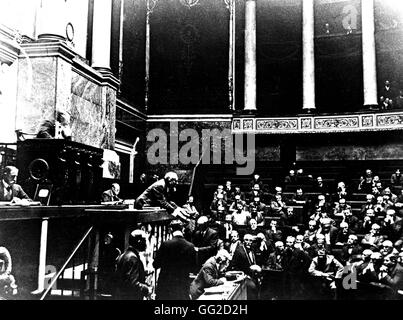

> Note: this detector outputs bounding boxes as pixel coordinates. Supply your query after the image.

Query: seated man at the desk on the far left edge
[0,166,31,202]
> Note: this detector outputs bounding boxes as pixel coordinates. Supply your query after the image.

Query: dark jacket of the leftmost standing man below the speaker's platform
[114,247,148,300]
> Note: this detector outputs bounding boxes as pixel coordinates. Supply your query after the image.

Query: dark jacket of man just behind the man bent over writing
[192,228,218,267]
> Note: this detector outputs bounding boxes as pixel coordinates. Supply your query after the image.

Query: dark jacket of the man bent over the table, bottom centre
[190,257,223,300]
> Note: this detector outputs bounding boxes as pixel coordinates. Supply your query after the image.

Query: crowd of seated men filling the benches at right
[187,169,403,299]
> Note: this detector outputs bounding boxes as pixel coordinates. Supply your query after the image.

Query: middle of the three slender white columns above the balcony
[302,0,316,112]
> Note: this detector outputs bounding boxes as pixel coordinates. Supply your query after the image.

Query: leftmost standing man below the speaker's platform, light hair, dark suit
[114,230,153,300]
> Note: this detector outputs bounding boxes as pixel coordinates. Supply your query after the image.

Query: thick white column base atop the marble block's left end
[37,0,67,40]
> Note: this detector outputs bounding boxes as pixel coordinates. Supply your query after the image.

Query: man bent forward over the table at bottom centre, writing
[190,249,231,300]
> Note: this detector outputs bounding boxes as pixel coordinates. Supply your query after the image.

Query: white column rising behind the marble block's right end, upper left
[92,0,112,71]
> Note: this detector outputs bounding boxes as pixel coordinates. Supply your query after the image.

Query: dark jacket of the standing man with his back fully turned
[154,236,196,300]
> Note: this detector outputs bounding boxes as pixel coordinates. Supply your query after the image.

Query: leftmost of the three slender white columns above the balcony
[244,0,256,112]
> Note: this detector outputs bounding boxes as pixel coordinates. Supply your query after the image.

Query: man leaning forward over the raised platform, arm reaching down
[135,172,189,220]
